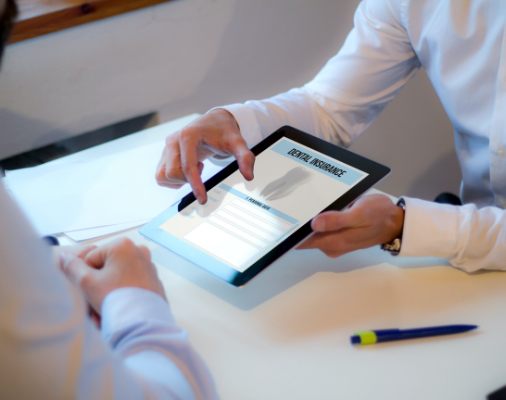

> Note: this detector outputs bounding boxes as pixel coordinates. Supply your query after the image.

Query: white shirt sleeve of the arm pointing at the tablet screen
[223,0,420,146]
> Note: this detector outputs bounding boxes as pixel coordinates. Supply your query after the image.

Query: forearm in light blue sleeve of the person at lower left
[102,288,216,399]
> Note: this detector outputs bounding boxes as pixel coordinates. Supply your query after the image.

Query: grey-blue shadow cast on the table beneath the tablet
[153,247,441,310]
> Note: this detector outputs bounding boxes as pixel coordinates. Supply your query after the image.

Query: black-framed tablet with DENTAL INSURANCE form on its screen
[140,126,390,286]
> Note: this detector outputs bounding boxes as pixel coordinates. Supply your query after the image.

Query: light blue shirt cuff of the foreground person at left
[101,287,176,347]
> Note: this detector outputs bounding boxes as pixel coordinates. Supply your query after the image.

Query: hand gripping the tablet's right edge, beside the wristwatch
[297,194,404,257]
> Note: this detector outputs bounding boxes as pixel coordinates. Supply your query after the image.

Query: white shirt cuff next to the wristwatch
[399,197,459,259]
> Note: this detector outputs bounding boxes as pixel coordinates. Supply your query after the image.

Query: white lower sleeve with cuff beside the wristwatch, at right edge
[400,197,506,272]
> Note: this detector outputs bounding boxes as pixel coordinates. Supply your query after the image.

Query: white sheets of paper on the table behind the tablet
[5,115,221,241]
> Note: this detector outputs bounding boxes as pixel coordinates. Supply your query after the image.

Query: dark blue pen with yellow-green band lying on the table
[350,325,478,344]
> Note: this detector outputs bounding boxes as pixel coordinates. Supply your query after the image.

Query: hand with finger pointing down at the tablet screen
[156,109,255,204]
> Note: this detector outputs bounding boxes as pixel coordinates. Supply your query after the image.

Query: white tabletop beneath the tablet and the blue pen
[65,117,506,400]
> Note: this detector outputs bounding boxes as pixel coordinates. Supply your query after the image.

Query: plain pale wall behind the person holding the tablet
[0,0,458,197]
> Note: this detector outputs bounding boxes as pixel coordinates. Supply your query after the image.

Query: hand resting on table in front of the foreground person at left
[60,239,165,313]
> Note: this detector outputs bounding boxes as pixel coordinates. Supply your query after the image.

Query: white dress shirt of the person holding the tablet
[224,0,506,271]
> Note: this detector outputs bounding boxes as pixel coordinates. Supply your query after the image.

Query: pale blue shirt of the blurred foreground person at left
[0,181,216,400]
